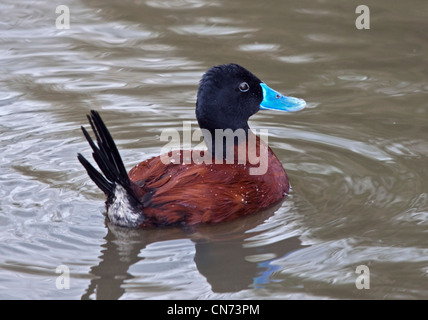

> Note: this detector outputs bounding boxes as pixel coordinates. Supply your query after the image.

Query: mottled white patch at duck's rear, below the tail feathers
[107,184,144,228]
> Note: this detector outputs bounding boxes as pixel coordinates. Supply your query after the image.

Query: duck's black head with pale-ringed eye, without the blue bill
[196,64,263,133]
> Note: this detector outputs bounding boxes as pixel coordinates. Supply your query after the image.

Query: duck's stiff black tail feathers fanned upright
[77,110,135,199]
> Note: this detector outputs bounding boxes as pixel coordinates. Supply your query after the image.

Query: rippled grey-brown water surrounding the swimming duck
[0,0,428,299]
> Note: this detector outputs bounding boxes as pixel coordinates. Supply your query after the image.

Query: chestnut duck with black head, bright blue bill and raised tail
[77,63,306,228]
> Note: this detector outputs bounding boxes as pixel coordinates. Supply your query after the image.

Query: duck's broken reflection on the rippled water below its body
[82,205,304,299]
